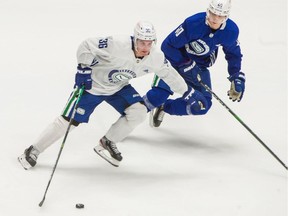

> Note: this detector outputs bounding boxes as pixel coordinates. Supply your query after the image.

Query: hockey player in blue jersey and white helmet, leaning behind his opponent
[144,0,245,127]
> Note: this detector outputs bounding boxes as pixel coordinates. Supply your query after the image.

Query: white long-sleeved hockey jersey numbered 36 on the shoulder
[77,35,187,95]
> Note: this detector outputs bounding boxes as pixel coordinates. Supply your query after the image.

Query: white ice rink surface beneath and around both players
[0,0,287,216]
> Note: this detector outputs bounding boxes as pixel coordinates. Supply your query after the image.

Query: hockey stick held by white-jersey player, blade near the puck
[39,86,84,207]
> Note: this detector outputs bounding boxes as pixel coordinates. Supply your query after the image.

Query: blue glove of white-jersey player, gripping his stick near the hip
[75,64,92,90]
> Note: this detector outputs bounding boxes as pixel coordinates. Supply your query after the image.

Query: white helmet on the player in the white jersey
[134,21,157,44]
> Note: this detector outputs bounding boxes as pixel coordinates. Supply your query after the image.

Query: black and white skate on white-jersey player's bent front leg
[94,136,122,167]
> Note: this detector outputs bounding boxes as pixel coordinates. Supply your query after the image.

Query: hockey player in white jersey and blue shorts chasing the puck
[18,21,207,169]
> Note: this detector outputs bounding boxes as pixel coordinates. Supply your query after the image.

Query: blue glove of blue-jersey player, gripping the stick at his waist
[178,59,201,86]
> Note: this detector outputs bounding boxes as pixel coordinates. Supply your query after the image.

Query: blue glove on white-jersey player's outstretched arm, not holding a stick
[182,86,208,115]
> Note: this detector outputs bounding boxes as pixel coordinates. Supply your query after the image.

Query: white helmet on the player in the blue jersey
[208,0,231,18]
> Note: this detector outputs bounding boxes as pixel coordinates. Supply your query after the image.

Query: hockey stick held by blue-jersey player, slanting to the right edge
[198,76,288,170]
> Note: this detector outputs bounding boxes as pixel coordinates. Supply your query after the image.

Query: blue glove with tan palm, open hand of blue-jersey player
[227,72,245,102]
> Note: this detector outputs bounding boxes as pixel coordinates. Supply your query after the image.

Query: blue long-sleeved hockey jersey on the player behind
[161,12,242,75]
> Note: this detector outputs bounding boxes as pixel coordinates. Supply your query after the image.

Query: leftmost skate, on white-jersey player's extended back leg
[18,145,40,170]
